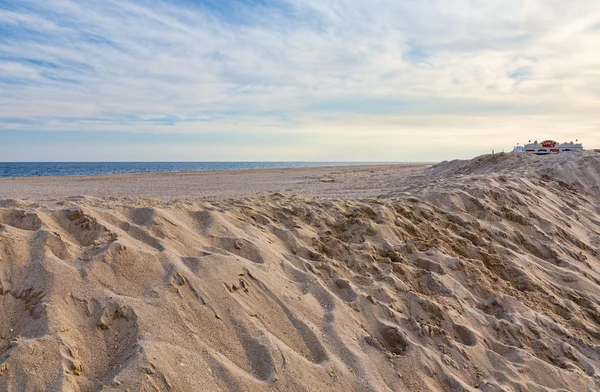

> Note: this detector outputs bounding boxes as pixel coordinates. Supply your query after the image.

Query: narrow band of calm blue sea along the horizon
[0,162,390,177]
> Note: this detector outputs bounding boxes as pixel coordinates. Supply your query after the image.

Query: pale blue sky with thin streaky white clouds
[0,0,600,162]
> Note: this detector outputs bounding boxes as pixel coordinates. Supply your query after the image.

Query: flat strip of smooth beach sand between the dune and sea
[0,164,430,200]
